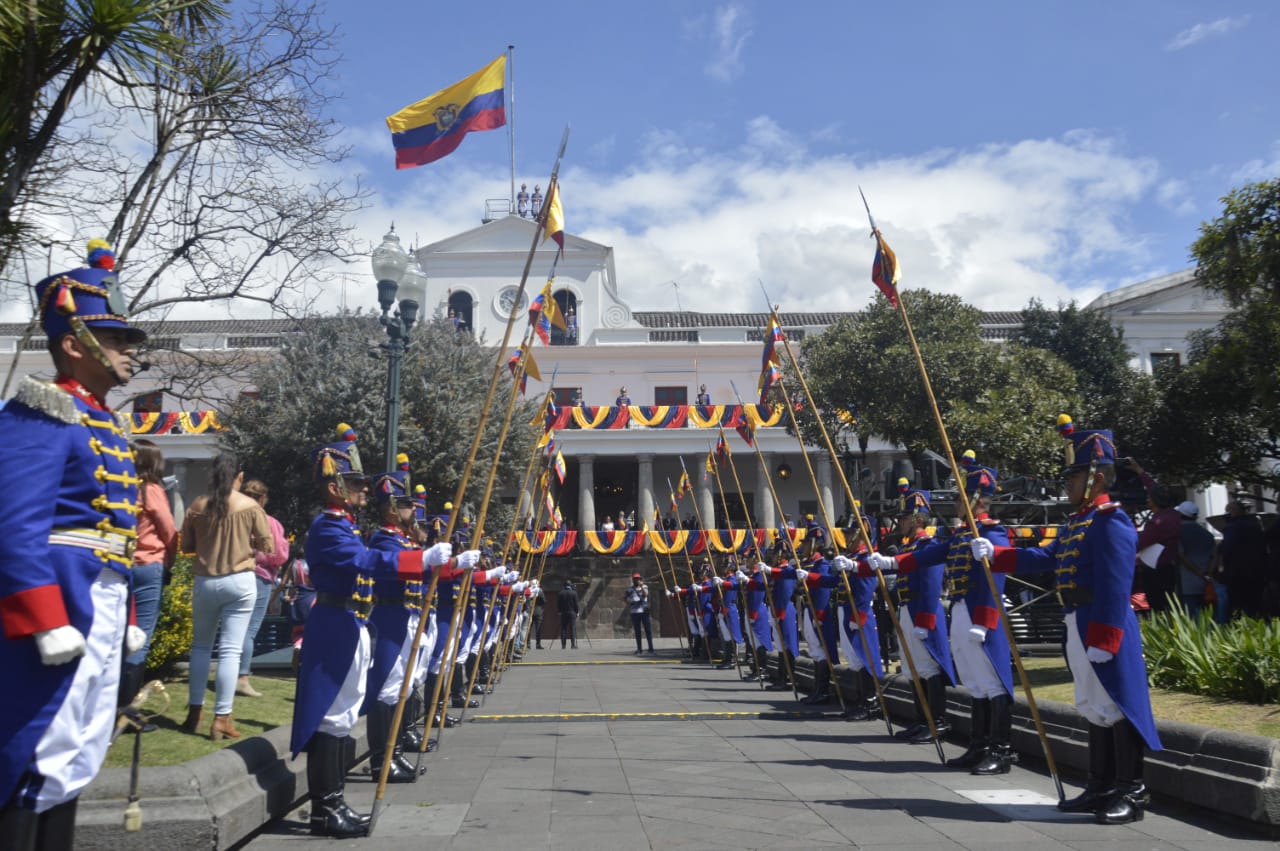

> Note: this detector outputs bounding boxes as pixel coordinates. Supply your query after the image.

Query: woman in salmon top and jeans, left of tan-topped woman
[119,440,178,706]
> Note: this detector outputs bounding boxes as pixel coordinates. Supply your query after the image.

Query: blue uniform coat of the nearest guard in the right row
[993,495,1161,751]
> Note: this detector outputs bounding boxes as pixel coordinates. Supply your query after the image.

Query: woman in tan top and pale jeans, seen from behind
[182,452,273,741]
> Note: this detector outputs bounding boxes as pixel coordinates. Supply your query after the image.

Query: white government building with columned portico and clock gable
[0,215,1226,530]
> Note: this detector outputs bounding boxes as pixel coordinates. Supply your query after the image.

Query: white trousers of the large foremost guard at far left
[28,568,129,808]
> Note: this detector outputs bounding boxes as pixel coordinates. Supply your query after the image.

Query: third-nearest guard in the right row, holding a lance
[864,488,956,745]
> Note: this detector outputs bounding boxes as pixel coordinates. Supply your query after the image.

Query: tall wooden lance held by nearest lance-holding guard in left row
[366,127,568,836]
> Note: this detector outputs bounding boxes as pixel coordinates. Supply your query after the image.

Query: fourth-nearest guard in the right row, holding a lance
[822,516,884,720]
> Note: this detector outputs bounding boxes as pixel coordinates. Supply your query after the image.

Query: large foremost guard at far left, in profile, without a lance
[0,241,146,851]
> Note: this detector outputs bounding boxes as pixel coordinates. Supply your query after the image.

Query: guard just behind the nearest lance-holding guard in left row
[364,453,422,783]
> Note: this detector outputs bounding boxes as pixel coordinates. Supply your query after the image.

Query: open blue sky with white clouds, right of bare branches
[307,0,1280,310]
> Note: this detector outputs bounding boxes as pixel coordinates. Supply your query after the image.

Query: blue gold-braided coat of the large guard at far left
[0,379,138,805]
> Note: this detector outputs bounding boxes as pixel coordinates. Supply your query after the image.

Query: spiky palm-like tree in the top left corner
[0,0,225,270]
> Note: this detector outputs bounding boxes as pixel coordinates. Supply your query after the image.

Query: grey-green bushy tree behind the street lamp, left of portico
[224,314,536,539]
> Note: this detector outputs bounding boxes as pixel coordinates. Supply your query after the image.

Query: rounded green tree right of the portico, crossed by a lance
[800,289,1076,476]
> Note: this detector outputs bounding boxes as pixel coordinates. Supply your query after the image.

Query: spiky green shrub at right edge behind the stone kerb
[1142,600,1280,704]
